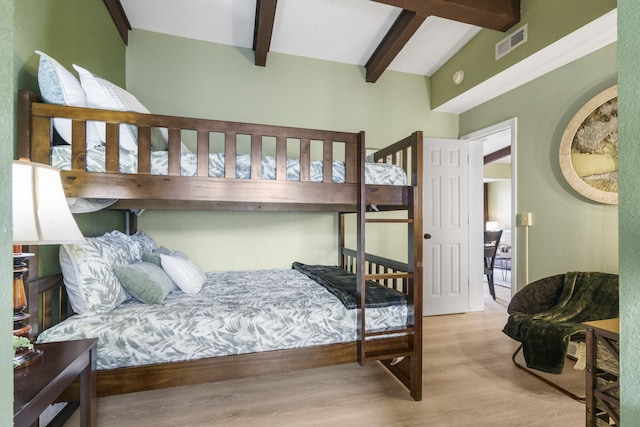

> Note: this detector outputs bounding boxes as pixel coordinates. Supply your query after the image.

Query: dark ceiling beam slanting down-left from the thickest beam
[365,10,426,83]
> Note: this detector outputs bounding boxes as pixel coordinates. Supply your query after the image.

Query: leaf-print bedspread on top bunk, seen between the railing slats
[51,145,407,185]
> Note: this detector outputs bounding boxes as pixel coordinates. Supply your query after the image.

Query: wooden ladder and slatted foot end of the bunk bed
[338,132,423,400]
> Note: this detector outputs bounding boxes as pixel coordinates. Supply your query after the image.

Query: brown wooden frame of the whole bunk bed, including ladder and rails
[18,90,422,401]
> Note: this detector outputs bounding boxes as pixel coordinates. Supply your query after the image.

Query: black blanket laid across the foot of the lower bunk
[291,262,407,309]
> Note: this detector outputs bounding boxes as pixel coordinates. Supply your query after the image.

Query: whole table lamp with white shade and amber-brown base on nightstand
[12,160,85,367]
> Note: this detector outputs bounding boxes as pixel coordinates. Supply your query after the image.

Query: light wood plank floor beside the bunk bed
[65,287,585,427]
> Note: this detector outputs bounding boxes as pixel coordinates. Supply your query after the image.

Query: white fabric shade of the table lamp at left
[13,160,85,245]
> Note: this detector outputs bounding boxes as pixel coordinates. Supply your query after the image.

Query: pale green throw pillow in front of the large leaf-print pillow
[113,262,176,304]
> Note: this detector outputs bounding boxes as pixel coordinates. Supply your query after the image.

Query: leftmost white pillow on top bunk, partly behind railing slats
[36,50,102,148]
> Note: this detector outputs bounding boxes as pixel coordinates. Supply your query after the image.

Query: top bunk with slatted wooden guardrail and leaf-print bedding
[18,90,422,212]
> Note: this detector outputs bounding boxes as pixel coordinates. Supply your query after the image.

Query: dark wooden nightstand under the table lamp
[13,339,98,427]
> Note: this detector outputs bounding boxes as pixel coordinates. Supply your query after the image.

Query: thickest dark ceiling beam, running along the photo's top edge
[374,0,520,31]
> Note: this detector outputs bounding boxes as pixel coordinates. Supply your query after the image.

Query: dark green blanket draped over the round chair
[503,272,618,374]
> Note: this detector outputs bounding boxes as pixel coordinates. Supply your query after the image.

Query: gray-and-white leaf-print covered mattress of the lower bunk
[38,269,407,369]
